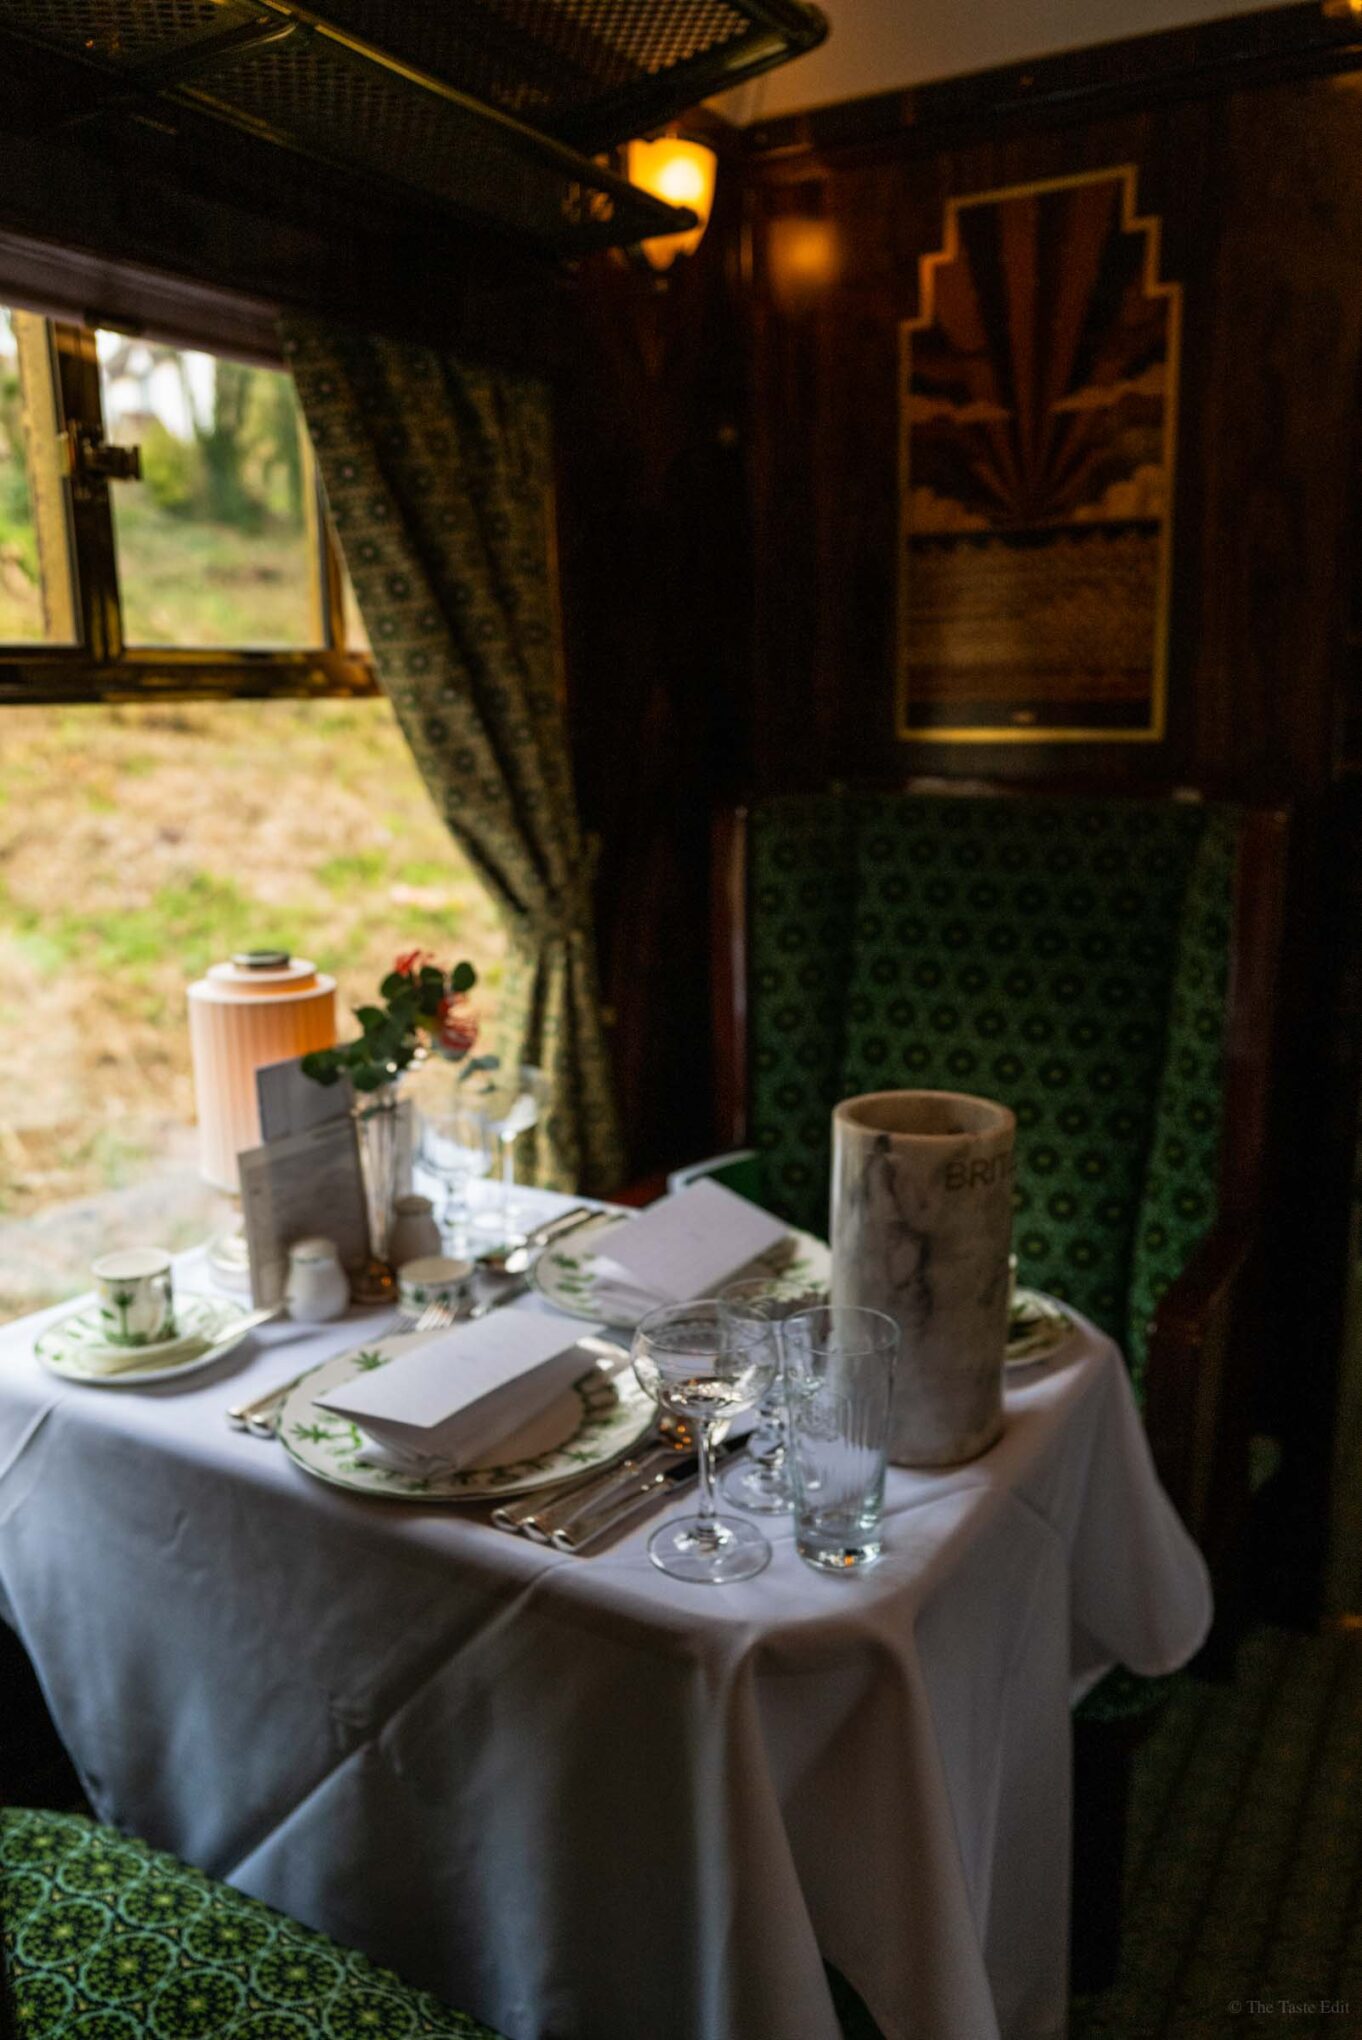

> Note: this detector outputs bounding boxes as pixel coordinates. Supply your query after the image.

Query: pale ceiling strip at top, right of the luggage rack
[716,0,1296,126]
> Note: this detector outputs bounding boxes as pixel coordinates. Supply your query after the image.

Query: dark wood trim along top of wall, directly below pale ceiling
[746,0,1362,167]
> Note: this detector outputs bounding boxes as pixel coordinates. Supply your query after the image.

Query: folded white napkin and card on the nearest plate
[318,1310,591,1471]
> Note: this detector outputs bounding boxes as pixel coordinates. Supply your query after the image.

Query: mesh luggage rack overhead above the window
[0,0,828,255]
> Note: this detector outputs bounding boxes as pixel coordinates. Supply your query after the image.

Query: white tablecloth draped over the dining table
[0,1191,1209,2040]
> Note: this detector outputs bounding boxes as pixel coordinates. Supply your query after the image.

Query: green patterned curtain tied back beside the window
[281,320,622,1191]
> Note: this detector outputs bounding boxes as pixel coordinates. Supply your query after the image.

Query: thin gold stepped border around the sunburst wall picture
[895,163,1183,745]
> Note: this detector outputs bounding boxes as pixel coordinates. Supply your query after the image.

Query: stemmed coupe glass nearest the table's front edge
[634,1297,777,1585]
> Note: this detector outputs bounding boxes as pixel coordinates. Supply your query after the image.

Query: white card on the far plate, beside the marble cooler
[597,1181,789,1304]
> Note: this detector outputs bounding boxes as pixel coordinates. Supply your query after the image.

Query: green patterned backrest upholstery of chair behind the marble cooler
[748,794,1240,1387]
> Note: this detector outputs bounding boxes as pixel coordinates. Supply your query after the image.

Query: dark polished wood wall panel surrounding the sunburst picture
[748,65,1362,794]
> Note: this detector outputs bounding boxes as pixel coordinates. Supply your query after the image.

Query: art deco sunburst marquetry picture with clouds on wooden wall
[897,165,1181,743]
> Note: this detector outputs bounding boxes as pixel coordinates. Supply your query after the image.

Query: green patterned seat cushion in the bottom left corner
[0,1807,495,2040]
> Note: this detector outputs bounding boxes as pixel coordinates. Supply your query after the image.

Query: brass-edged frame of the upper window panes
[0,308,381,706]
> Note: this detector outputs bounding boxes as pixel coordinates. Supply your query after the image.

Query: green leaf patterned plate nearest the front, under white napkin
[277,1334,657,1501]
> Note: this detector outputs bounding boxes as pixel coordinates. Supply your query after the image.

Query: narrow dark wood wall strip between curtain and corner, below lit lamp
[557,169,750,1175]
